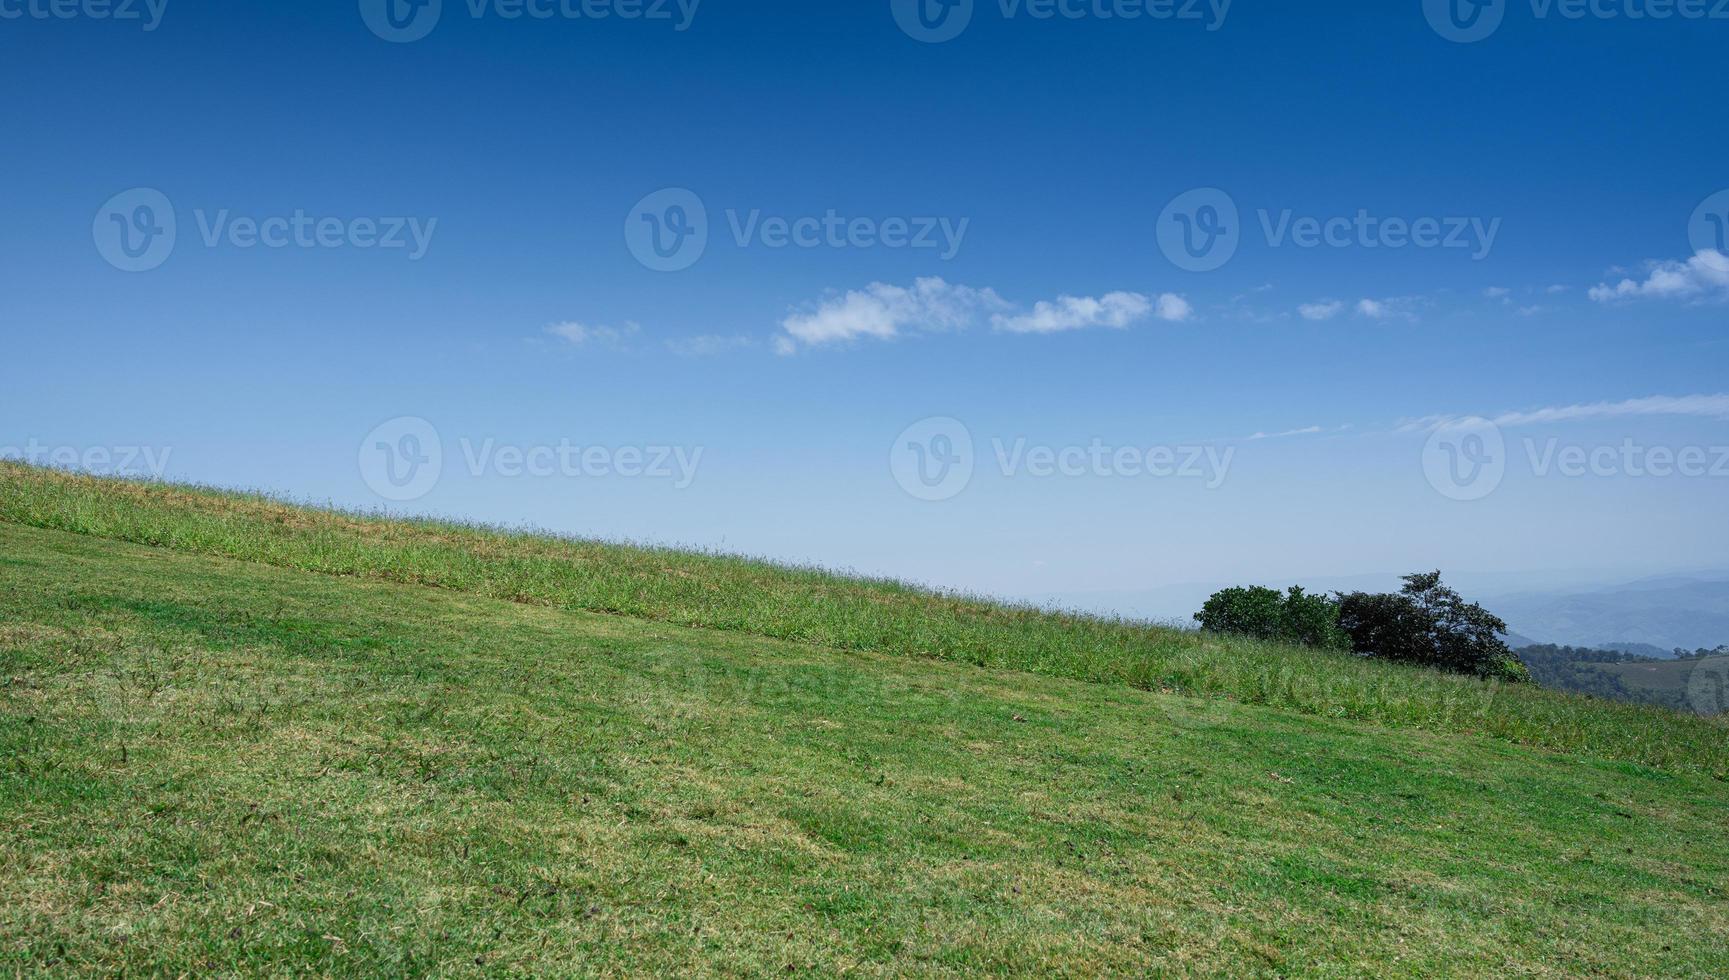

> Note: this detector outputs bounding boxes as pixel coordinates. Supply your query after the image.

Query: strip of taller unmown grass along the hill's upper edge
[0,463,1729,778]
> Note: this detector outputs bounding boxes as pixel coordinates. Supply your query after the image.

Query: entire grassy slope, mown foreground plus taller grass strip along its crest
[0,467,1729,977]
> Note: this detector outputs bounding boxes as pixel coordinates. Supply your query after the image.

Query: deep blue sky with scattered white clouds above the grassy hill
[0,0,1729,615]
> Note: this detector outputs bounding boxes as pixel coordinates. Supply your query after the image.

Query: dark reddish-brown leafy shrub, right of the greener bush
[1338,572,1530,683]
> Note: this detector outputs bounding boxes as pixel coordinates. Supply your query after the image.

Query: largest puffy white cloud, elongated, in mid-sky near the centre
[773,277,1193,354]
